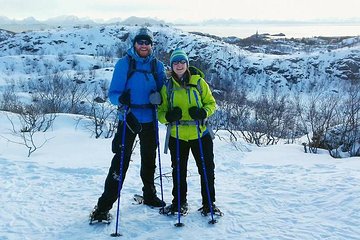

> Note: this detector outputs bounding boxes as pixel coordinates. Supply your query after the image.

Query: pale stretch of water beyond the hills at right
[176,23,360,38]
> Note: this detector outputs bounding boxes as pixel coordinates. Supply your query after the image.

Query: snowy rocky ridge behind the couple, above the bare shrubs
[0,24,360,97]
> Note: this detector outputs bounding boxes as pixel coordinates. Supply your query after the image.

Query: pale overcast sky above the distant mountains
[0,0,360,22]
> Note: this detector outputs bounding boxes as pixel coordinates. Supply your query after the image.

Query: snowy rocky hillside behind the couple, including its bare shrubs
[0,24,360,157]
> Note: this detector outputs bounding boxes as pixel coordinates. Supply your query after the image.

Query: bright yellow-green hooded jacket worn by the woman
[158,75,216,141]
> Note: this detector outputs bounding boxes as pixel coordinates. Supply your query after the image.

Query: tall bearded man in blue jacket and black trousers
[91,27,166,220]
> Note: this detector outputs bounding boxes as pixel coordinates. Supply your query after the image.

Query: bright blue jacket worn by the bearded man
[109,47,166,123]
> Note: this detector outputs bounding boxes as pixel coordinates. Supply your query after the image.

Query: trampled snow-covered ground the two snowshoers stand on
[0,112,360,240]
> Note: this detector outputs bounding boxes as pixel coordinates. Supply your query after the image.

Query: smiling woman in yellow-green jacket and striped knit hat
[158,49,220,215]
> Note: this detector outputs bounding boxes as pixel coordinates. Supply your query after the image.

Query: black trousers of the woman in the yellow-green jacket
[169,134,215,205]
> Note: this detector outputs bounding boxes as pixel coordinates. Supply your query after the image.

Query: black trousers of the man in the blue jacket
[98,122,157,211]
